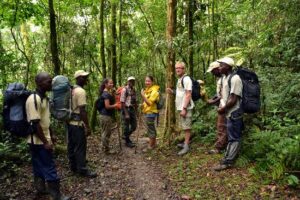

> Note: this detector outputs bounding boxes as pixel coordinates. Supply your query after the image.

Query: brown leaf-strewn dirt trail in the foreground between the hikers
[0,121,179,200]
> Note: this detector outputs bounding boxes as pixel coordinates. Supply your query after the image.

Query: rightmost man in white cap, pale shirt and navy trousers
[214,57,244,171]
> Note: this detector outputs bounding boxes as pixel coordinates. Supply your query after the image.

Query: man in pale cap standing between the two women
[120,76,138,148]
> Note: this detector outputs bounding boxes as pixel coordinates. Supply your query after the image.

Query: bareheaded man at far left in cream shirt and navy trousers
[24,72,70,200]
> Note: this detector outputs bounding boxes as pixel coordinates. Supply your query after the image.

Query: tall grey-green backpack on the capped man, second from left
[50,75,73,121]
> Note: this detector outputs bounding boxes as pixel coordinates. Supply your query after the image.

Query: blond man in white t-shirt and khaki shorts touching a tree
[167,62,194,155]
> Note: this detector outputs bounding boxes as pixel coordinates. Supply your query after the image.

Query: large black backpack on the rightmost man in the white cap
[228,67,260,113]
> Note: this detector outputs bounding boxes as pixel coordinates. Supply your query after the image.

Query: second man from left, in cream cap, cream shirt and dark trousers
[68,70,97,178]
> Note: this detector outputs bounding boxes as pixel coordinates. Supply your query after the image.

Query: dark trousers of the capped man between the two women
[122,107,137,138]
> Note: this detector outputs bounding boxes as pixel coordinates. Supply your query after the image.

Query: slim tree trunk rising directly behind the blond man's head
[187,0,194,76]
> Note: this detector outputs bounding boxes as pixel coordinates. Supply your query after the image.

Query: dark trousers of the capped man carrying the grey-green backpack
[68,124,86,172]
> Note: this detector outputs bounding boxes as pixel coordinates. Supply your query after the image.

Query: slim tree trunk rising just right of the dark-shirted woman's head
[111,0,117,83]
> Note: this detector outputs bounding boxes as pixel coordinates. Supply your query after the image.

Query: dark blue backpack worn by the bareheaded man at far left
[2,83,37,137]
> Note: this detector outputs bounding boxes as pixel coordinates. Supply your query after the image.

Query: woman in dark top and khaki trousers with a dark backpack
[97,78,117,154]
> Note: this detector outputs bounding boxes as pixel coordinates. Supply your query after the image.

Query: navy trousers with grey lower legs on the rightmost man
[223,111,244,164]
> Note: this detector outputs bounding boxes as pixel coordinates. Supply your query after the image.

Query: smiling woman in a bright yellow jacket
[141,76,159,149]
